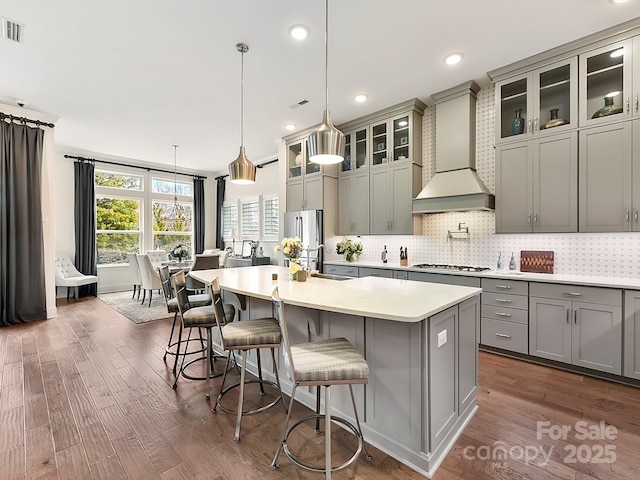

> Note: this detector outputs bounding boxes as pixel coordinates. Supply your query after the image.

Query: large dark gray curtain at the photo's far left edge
[0,121,47,326]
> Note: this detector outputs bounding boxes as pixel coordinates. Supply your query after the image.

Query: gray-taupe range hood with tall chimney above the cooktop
[412,80,495,213]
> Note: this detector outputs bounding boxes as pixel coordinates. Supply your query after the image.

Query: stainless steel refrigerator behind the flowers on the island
[284,210,324,272]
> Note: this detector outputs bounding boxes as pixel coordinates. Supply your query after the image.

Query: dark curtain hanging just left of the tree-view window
[73,162,98,297]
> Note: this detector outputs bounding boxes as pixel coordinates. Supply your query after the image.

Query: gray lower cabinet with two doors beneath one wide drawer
[529,283,622,375]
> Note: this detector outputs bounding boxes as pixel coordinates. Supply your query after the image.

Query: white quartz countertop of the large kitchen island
[189,265,482,322]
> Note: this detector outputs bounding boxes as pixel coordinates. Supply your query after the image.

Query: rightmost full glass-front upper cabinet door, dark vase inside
[580,39,635,126]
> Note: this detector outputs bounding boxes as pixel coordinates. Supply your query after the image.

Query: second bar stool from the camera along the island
[211,278,287,442]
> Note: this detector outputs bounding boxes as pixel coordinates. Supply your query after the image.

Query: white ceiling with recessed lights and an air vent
[0,0,640,172]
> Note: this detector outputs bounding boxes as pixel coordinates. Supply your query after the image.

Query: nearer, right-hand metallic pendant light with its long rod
[307,0,344,165]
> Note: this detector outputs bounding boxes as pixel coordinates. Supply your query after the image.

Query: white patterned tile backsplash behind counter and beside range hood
[325,86,640,278]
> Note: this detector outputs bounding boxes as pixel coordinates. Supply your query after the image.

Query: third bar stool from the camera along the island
[171,272,235,398]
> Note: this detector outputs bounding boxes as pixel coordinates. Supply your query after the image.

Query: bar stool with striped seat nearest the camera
[271,287,371,480]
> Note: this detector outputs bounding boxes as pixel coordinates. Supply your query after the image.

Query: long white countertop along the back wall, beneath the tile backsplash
[325,260,640,290]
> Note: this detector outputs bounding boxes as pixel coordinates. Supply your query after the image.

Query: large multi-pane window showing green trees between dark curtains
[95,167,193,265]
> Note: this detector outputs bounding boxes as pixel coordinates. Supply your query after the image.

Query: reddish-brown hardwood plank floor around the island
[0,298,640,480]
